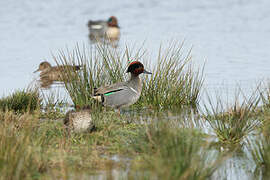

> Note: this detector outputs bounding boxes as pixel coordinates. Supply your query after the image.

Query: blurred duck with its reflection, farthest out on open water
[87,16,120,42]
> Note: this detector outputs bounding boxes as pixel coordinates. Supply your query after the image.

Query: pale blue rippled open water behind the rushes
[0,0,270,95]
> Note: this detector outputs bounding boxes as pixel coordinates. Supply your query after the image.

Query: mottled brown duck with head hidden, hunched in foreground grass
[64,108,94,133]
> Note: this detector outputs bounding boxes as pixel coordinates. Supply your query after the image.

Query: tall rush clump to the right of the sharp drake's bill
[140,43,204,109]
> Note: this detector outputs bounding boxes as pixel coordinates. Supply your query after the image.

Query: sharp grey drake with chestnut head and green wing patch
[92,61,152,114]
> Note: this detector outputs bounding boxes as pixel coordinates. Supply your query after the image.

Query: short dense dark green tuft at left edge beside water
[0,90,41,113]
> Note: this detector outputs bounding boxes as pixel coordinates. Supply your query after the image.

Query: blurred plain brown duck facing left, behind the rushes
[34,61,81,88]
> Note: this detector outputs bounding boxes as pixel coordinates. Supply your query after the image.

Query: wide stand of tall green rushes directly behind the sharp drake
[54,43,203,108]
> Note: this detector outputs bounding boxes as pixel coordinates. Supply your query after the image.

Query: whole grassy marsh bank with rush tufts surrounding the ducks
[0,44,270,179]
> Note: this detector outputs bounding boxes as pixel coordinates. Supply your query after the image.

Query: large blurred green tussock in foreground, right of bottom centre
[130,121,225,179]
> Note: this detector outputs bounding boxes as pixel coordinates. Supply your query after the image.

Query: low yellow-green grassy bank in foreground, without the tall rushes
[0,107,225,179]
